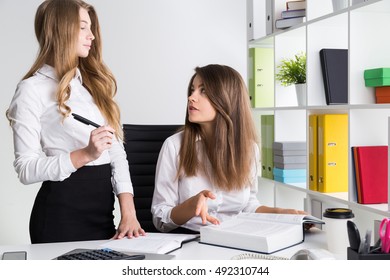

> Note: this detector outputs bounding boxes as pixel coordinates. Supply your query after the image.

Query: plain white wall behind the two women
[0,0,247,245]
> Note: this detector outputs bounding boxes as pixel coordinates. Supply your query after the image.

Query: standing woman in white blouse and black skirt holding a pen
[7,0,144,243]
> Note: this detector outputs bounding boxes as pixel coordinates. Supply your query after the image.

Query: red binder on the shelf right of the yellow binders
[354,146,388,204]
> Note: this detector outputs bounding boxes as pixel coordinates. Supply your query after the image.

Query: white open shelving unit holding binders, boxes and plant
[248,0,390,233]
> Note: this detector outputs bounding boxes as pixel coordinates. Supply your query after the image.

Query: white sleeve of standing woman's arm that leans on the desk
[109,141,134,195]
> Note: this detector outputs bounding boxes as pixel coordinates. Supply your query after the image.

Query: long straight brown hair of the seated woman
[178,64,257,190]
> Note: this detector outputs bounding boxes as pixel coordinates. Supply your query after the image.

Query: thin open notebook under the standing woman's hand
[100,232,199,254]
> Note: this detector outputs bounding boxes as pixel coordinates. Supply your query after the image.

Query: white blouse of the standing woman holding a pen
[9,65,133,194]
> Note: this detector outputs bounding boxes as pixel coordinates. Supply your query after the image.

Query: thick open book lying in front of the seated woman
[200,213,324,254]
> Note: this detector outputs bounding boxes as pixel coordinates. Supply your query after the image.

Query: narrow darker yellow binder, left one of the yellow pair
[309,115,318,191]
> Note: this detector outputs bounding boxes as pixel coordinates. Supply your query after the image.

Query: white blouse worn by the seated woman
[152,132,260,232]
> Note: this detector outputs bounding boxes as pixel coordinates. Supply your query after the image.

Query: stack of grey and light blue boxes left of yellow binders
[273,141,307,186]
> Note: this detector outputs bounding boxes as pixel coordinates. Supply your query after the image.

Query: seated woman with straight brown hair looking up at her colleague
[152,65,305,232]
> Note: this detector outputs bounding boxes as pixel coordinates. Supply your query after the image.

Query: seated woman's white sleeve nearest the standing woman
[152,138,179,232]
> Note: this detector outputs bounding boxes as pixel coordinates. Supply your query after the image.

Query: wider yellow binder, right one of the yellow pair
[317,114,348,193]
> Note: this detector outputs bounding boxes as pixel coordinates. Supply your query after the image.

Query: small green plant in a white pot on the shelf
[275,52,306,105]
